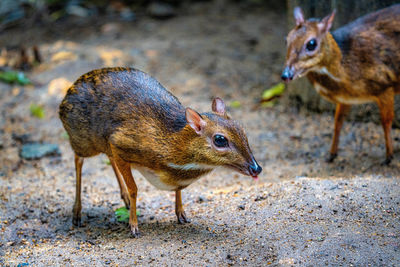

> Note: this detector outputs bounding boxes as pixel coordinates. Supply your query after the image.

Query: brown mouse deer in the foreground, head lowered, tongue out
[59,68,262,236]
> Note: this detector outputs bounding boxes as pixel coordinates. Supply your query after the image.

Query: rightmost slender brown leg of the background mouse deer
[377,88,394,165]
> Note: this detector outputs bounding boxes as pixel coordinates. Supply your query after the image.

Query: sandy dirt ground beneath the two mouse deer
[0,3,400,266]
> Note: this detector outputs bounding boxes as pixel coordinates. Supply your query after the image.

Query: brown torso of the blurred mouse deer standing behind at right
[332,4,400,94]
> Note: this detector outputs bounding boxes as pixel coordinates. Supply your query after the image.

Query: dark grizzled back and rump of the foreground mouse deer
[60,68,186,156]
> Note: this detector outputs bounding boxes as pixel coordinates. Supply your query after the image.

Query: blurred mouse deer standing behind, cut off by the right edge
[282,4,400,164]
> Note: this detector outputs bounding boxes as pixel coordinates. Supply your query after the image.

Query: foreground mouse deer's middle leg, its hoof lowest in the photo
[110,151,139,237]
